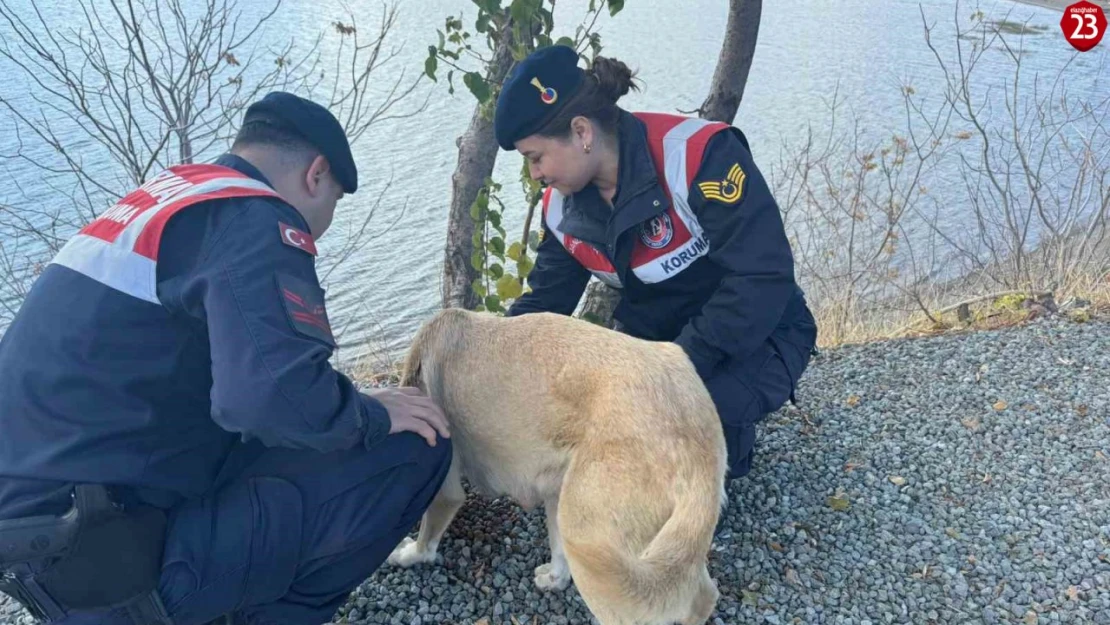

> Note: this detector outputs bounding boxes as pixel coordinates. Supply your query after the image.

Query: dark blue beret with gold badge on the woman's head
[493,46,586,150]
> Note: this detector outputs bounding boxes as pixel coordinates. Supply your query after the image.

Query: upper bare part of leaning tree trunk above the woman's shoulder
[698,0,763,123]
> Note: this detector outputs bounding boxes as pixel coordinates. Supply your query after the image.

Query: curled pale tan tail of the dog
[564,463,726,614]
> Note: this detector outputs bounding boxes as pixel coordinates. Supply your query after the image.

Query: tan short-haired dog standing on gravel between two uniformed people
[390,309,726,625]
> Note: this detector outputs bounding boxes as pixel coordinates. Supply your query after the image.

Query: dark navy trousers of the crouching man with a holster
[54,433,451,625]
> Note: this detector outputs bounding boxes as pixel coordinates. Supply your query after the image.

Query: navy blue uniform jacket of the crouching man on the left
[0,154,390,518]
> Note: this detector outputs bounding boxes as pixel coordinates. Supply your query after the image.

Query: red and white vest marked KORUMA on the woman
[543,113,729,289]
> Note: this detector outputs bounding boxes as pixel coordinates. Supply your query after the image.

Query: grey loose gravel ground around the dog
[0,317,1110,625]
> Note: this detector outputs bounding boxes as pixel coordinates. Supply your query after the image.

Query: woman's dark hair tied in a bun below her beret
[536,57,639,142]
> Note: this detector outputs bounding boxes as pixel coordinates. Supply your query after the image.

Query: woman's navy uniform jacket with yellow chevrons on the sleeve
[508,111,816,382]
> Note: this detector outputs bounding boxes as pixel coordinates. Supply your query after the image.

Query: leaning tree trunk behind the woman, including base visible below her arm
[581,0,763,327]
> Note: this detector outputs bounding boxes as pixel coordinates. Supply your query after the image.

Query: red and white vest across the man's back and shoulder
[50,164,279,304]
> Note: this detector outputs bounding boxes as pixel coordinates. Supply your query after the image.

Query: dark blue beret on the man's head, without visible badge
[243,91,359,193]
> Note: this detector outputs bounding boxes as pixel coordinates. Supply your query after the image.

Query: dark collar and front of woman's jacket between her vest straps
[563,110,667,249]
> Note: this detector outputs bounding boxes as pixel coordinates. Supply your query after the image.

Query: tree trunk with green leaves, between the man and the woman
[442,20,514,310]
